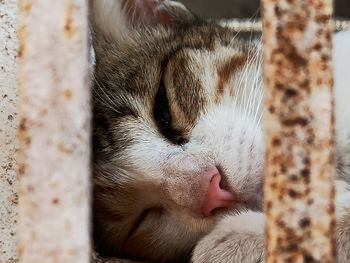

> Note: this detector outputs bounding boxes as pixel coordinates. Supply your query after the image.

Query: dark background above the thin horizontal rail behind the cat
[178,0,350,18]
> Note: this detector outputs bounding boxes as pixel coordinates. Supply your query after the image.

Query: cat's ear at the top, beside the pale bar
[90,0,194,38]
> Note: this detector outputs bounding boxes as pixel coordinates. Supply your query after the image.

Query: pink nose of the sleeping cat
[201,168,234,216]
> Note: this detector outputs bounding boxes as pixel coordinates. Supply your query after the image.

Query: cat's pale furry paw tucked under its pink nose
[192,212,264,263]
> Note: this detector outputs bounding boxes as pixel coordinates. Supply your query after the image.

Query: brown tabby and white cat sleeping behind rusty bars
[90,0,350,263]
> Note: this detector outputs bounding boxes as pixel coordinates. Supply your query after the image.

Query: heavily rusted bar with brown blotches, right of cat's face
[262,0,335,262]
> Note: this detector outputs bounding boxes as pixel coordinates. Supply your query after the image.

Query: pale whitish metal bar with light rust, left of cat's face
[18,0,90,263]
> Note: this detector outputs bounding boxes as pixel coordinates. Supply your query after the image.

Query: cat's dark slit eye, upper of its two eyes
[153,81,187,145]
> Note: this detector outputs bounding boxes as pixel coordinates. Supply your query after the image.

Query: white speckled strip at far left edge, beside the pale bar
[0,0,18,263]
